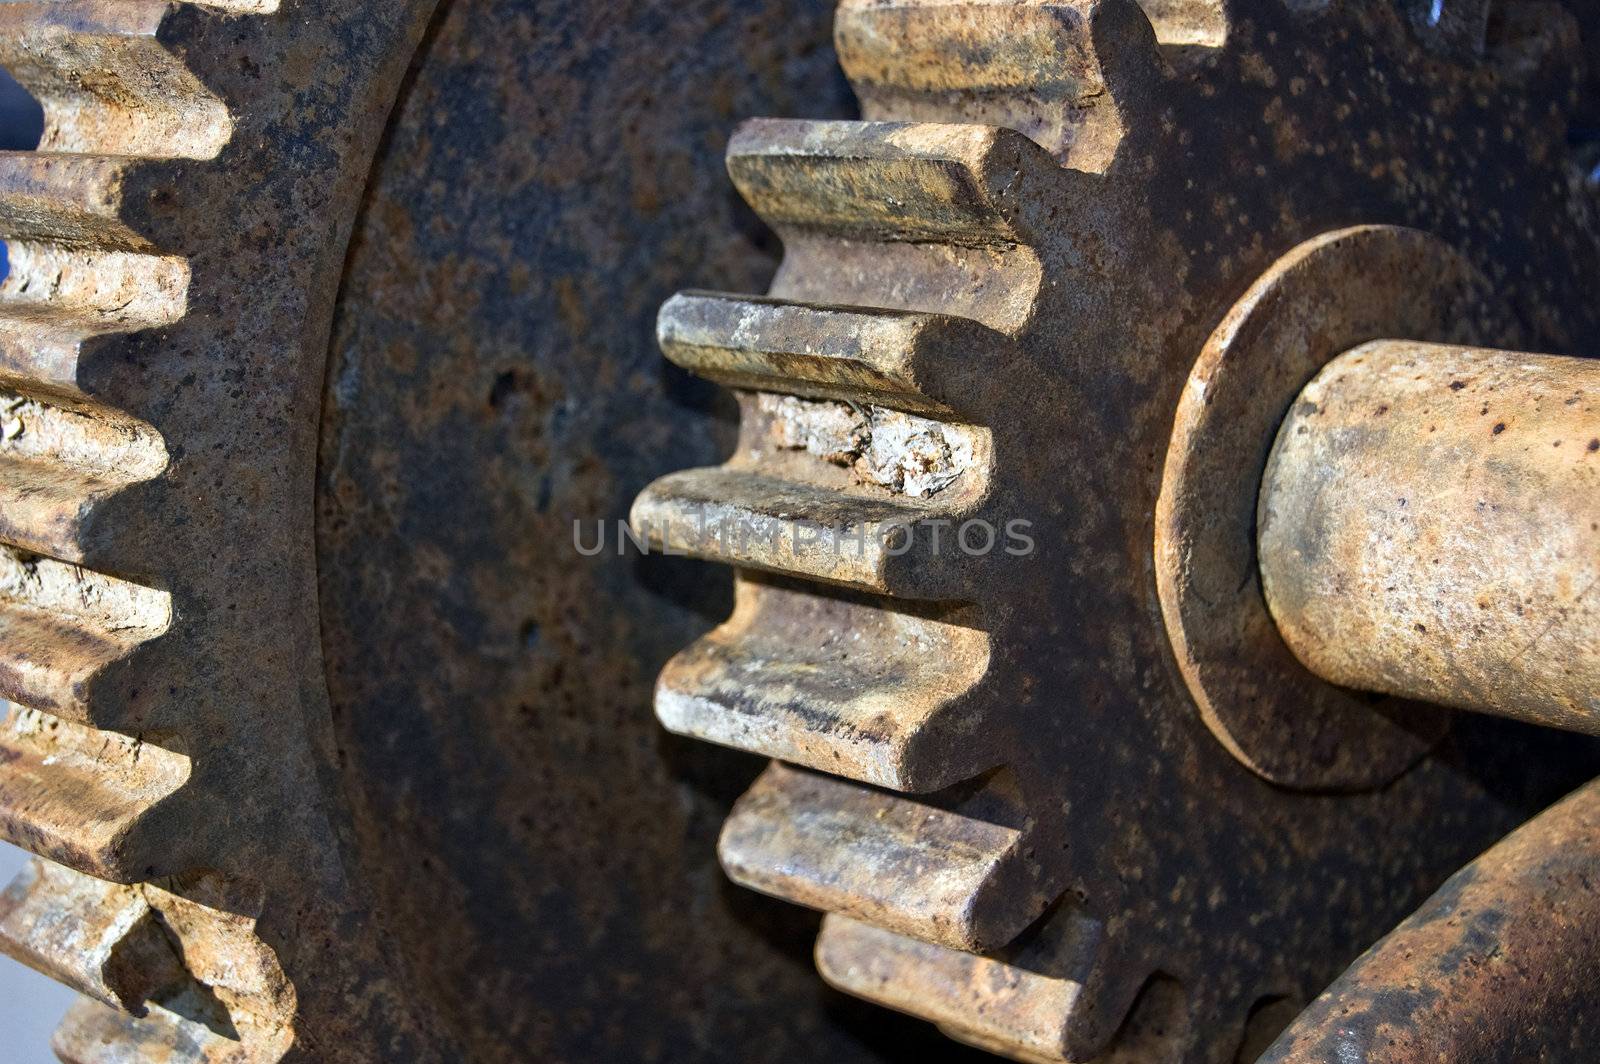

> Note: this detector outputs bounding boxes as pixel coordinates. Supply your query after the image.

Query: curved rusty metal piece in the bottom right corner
[1261,771,1600,1064]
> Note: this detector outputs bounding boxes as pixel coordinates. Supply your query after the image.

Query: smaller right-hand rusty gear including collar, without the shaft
[632,0,1600,1061]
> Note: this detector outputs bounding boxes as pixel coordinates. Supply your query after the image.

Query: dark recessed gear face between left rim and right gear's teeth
[317,0,966,1061]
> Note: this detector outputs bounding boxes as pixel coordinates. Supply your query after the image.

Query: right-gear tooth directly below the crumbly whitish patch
[630,466,973,598]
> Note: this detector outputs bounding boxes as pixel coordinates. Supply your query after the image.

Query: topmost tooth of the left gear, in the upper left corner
[0,0,233,158]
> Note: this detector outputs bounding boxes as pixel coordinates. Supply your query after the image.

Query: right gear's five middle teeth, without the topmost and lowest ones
[632,120,1059,949]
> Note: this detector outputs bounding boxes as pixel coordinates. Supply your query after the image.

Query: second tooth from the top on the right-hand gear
[728,118,1040,246]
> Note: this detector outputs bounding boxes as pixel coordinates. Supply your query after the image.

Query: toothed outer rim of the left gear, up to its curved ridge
[0,0,438,1064]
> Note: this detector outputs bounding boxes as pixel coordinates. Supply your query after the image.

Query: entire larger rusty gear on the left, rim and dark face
[0,0,960,1064]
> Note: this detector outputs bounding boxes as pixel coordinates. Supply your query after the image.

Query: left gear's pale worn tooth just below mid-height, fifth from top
[0,549,171,728]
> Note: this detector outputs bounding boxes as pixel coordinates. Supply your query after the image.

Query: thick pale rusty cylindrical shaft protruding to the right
[1258,341,1600,733]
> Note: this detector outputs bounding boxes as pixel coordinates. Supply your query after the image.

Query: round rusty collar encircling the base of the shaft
[1155,226,1507,790]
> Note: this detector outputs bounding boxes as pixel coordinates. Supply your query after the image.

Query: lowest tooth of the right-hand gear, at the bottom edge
[816,914,1142,1064]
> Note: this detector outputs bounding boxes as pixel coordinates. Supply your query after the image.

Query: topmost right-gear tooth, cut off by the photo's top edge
[834,0,1171,173]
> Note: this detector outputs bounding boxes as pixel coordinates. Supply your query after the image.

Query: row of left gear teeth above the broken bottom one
[0,0,212,896]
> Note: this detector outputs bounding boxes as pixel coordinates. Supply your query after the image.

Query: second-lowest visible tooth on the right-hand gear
[717,762,1043,950]
